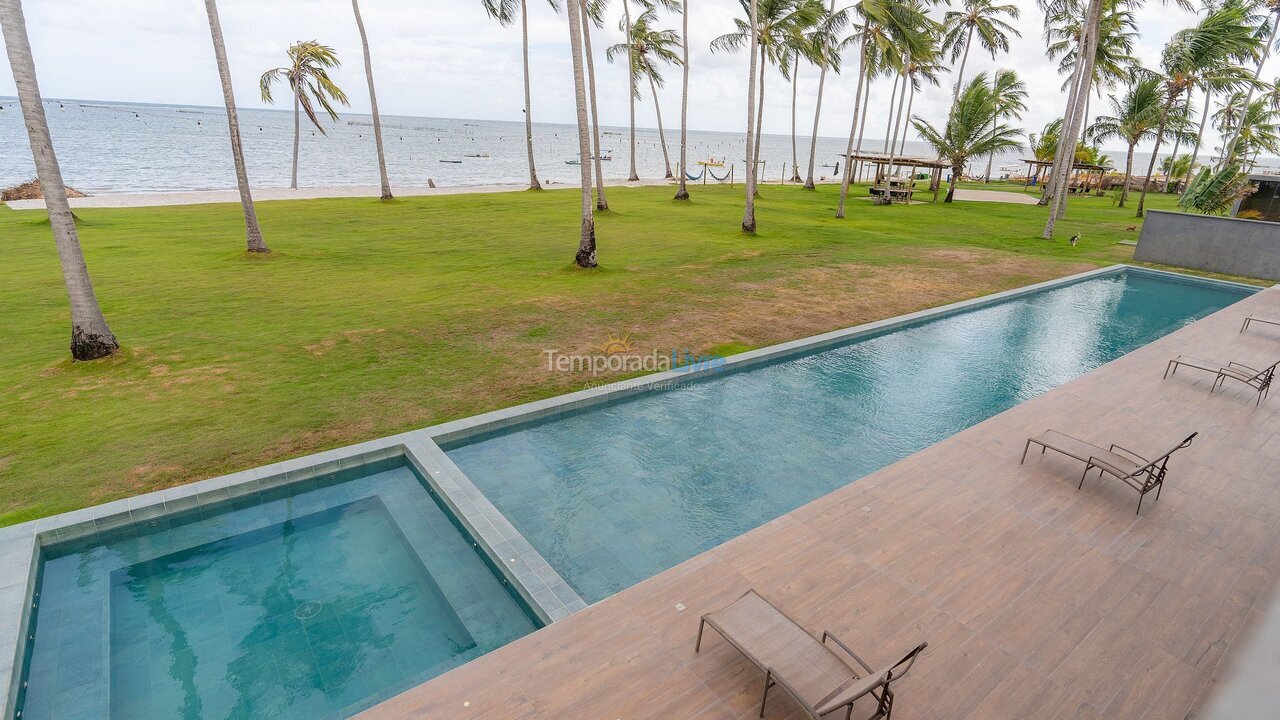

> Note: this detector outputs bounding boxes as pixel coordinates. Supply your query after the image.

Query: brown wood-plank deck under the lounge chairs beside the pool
[361,283,1280,720]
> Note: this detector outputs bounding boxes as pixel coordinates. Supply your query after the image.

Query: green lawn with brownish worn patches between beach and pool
[0,186,1254,524]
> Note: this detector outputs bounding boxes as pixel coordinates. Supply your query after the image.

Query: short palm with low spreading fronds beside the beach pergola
[913,73,1023,202]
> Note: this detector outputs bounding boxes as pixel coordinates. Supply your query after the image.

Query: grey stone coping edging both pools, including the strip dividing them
[0,264,1259,717]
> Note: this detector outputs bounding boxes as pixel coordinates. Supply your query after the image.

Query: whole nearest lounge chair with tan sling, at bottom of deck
[694,589,928,720]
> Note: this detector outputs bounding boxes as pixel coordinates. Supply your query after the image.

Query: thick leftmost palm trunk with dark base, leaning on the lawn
[0,0,120,360]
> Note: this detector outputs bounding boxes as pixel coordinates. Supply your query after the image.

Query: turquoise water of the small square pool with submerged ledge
[19,459,536,720]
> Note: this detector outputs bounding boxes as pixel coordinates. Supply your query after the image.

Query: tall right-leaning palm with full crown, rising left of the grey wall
[1137,0,1263,218]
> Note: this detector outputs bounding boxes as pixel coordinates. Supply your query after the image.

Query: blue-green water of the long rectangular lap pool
[445,272,1249,602]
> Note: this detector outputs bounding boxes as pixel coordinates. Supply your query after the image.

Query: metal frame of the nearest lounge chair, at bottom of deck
[694,589,929,720]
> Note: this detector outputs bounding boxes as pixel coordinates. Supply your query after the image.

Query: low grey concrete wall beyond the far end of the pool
[1133,210,1280,281]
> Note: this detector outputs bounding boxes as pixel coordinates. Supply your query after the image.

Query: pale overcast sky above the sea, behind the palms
[0,0,1280,152]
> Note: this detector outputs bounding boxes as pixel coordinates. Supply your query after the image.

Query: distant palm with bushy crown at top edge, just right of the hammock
[712,0,827,189]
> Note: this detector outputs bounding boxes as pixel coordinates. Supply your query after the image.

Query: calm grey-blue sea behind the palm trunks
[0,97,1044,193]
